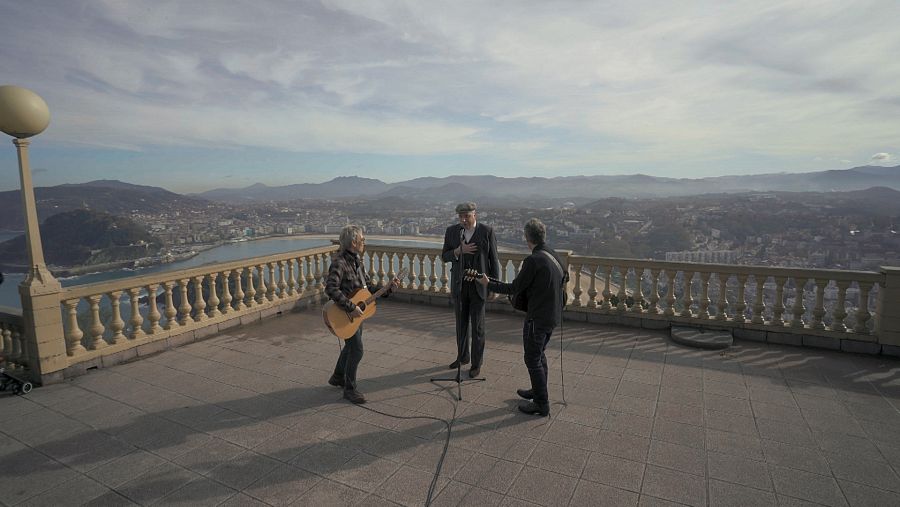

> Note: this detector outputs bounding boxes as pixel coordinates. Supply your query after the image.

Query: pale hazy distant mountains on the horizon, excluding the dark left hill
[191,166,900,204]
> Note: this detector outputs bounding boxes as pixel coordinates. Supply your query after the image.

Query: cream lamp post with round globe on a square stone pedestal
[0,86,67,382]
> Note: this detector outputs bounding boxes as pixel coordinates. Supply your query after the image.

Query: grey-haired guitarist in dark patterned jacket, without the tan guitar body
[325,225,400,404]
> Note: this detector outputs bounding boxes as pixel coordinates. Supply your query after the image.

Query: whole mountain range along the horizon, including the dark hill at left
[0,166,900,230]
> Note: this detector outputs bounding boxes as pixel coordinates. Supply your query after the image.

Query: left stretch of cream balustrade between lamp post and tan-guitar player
[60,246,336,367]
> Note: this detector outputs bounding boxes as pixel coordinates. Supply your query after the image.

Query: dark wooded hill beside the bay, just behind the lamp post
[0,210,162,266]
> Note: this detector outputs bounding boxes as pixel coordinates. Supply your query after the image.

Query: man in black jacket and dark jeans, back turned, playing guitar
[478,218,568,416]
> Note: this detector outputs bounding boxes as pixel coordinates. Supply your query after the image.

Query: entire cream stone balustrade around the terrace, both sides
[8,244,900,380]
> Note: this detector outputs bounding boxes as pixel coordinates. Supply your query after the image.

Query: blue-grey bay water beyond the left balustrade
[0,236,441,309]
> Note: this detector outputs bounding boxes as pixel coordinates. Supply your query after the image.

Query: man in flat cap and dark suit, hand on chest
[441,202,500,377]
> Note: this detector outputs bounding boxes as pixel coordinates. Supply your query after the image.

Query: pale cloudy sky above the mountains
[0,0,900,193]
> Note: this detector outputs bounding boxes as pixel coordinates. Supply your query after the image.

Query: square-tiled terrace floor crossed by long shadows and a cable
[0,301,900,507]
